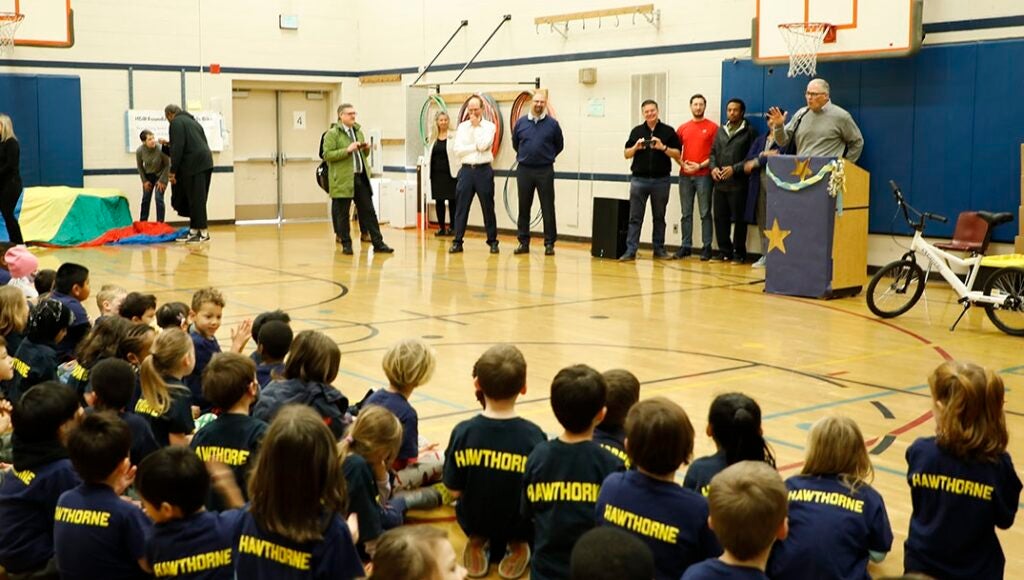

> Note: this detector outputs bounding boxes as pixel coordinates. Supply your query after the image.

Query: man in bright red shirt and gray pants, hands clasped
[673,94,718,261]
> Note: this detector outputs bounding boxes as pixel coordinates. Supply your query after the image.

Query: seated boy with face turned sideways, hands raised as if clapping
[185,288,252,413]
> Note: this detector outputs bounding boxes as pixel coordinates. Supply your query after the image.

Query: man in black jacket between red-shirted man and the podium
[710,98,758,263]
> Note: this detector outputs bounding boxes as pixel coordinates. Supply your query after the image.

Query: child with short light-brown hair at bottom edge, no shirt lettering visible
[682,461,786,580]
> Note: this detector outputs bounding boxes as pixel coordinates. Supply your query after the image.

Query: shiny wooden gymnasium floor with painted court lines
[39,223,1024,578]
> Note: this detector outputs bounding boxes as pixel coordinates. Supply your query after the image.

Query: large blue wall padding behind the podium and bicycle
[722,40,1024,242]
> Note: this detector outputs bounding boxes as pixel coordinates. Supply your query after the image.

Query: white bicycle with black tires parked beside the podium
[867,181,1024,336]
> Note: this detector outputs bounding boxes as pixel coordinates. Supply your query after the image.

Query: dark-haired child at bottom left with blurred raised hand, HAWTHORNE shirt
[135,447,243,580]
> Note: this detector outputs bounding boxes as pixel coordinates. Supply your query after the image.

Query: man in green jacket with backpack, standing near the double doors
[324,102,394,254]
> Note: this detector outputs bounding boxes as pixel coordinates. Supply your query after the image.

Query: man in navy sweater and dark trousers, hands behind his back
[512,89,565,256]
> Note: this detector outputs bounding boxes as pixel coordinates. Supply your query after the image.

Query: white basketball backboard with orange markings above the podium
[752,0,924,65]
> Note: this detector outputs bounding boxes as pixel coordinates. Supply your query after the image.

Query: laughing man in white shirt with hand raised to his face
[449,96,498,254]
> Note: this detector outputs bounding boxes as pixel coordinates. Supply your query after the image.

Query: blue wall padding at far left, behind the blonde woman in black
[0,75,83,188]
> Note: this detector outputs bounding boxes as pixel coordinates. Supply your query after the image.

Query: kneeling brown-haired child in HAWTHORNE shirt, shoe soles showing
[444,344,547,578]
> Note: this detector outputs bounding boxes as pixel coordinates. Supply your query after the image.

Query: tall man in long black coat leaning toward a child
[164,105,213,244]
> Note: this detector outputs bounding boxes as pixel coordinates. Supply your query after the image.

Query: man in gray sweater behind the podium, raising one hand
[768,79,864,162]
